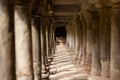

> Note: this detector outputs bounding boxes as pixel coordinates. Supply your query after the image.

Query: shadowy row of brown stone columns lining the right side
[66,0,120,80]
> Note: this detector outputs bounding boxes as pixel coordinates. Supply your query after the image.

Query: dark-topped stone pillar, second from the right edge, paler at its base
[99,8,111,77]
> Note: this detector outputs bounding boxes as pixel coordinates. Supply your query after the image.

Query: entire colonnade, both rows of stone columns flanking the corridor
[0,0,120,80]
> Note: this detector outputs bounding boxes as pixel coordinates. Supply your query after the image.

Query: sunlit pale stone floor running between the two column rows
[49,42,110,80]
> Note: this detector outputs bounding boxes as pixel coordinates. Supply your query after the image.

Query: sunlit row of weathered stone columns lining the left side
[0,0,54,80]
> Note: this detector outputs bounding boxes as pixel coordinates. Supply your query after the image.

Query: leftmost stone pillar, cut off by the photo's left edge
[0,0,15,80]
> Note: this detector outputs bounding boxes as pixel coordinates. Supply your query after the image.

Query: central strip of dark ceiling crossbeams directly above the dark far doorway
[52,0,80,26]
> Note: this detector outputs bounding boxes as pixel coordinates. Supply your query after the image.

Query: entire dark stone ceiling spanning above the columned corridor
[29,0,111,26]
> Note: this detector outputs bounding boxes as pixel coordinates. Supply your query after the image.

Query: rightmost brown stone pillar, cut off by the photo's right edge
[111,0,120,80]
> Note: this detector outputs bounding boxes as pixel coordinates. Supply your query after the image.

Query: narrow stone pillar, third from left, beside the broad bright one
[32,18,41,80]
